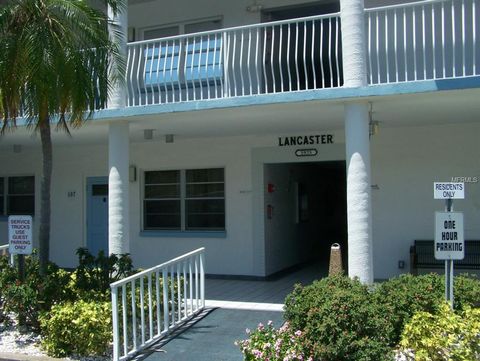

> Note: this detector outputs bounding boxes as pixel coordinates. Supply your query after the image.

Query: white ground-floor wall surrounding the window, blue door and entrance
[0,123,480,279]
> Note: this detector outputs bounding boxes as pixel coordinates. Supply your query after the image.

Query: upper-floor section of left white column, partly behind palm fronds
[108,6,128,109]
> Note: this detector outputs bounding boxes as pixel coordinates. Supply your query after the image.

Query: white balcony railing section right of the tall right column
[365,0,480,84]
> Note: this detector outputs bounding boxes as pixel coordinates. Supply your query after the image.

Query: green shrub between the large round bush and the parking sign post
[372,273,445,346]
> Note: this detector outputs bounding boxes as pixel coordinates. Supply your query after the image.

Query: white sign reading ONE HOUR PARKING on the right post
[435,212,465,260]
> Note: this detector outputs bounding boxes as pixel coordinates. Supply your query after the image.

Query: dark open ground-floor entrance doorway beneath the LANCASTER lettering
[264,161,348,275]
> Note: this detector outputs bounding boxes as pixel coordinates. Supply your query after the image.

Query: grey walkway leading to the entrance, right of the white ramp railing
[136,264,327,361]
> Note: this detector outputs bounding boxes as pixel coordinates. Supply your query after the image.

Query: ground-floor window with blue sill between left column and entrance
[143,168,225,231]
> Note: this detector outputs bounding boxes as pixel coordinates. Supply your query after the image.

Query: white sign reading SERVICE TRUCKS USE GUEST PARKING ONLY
[8,216,32,254]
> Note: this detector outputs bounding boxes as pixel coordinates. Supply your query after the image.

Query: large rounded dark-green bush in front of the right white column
[285,276,392,361]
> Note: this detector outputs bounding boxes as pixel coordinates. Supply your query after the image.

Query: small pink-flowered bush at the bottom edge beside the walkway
[235,321,312,361]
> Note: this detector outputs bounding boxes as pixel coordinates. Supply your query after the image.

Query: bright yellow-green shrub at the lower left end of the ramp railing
[40,300,112,357]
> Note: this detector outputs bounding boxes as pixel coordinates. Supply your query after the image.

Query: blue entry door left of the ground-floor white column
[87,177,108,256]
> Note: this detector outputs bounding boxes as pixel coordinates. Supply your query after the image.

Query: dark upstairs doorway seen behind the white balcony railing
[262,0,343,92]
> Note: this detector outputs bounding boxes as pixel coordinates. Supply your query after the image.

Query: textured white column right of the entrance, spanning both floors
[340,0,373,284]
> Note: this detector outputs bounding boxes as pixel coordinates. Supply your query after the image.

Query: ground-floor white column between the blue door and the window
[108,120,130,254]
